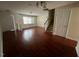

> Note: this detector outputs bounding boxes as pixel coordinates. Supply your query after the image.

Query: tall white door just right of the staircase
[54,8,71,37]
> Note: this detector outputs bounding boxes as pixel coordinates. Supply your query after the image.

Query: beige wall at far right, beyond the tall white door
[66,7,79,56]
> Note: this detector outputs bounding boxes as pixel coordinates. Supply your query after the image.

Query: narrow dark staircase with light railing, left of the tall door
[44,9,55,32]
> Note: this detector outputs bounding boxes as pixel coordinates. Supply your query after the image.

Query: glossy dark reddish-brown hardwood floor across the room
[3,27,77,57]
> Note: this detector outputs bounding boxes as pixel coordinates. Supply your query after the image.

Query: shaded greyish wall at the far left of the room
[0,11,14,31]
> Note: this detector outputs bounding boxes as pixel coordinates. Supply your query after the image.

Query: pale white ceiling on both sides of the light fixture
[0,1,75,15]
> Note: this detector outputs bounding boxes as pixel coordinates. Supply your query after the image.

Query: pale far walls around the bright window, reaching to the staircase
[14,13,48,29]
